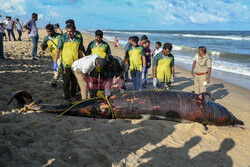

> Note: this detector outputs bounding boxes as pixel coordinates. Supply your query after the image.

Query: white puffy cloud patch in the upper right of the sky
[147,0,250,24]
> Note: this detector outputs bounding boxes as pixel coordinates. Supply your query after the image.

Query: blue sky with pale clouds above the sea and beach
[0,0,250,30]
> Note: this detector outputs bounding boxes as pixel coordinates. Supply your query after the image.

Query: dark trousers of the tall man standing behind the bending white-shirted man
[63,68,77,99]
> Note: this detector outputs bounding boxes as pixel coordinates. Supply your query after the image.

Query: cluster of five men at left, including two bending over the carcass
[41,19,125,100]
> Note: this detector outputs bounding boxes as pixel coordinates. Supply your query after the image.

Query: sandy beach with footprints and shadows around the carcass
[0,30,250,167]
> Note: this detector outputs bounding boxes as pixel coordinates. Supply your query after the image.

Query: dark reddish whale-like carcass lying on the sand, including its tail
[8,90,244,126]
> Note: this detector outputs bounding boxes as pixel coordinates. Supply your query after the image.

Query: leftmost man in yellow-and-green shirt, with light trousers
[41,24,62,87]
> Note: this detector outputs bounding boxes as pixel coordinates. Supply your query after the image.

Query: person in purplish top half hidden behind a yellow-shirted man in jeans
[142,40,151,88]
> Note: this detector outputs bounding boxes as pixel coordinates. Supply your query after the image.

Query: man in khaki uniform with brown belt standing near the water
[191,46,212,94]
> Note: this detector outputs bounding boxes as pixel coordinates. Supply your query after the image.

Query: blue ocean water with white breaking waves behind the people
[83,29,250,90]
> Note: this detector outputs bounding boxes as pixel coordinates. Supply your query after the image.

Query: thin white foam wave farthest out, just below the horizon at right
[174,34,250,41]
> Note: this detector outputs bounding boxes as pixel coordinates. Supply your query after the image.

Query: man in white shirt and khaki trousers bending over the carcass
[71,54,106,100]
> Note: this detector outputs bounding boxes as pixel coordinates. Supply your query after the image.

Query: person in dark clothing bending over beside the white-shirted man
[104,55,125,96]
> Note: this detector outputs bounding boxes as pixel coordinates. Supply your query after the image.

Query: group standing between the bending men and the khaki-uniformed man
[125,35,175,90]
